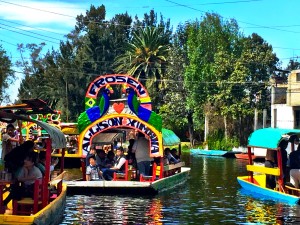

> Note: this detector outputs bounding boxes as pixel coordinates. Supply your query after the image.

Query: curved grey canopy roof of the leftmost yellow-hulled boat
[0,110,67,149]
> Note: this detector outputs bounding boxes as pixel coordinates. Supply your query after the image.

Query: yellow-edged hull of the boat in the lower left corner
[0,185,67,225]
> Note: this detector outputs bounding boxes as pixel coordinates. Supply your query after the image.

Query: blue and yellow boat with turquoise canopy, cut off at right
[237,128,300,204]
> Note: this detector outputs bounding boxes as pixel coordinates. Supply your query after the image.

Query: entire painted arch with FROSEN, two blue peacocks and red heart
[78,74,163,157]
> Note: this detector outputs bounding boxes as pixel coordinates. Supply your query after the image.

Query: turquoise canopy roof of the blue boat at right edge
[248,128,300,149]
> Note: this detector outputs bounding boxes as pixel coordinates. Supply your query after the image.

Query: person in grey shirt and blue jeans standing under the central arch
[132,132,152,176]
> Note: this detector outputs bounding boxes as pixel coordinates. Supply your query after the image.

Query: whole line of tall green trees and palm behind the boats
[0,5,299,148]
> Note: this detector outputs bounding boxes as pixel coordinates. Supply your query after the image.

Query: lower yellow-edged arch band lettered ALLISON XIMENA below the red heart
[78,114,163,157]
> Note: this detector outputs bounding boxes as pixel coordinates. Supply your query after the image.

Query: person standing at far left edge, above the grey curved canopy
[1,124,19,159]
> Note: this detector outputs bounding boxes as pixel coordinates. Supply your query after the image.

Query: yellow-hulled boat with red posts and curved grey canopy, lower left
[0,99,67,225]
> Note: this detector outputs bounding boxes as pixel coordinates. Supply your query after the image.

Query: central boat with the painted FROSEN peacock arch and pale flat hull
[66,74,190,194]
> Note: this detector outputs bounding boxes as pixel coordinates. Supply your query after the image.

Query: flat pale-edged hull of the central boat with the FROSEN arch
[66,167,190,195]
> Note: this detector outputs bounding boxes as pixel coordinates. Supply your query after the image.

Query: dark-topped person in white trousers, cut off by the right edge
[289,145,300,188]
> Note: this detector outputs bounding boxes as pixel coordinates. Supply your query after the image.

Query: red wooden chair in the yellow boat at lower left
[13,179,43,215]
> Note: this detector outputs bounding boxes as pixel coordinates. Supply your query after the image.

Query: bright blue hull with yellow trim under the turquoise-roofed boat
[237,175,299,204]
